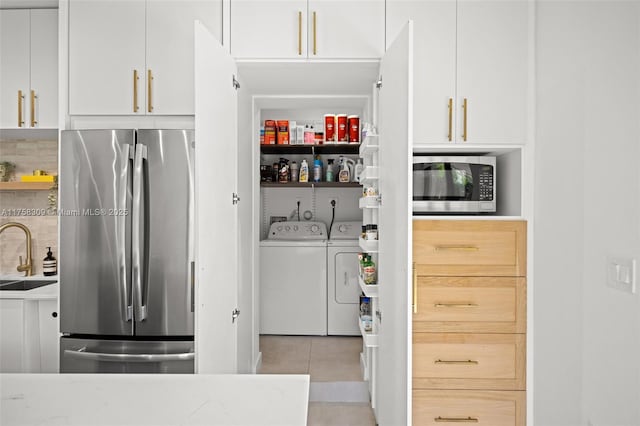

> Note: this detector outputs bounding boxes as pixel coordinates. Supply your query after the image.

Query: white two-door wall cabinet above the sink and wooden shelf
[0,9,58,129]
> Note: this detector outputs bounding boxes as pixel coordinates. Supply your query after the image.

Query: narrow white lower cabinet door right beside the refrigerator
[38,300,60,373]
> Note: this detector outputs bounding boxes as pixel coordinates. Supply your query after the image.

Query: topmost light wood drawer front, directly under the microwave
[413,220,526,276]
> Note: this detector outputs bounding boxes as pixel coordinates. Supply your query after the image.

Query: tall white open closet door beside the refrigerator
[195,22,241,374]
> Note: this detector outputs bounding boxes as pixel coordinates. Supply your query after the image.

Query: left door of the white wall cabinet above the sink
[0,9,29,129]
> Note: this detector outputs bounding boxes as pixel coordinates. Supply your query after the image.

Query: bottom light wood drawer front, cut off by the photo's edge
[413,390,526,426]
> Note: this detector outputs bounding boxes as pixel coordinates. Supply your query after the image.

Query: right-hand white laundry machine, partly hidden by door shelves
[327,221,362,336]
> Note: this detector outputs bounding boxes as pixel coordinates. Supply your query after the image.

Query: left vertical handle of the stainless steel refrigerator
[116,145,134,322]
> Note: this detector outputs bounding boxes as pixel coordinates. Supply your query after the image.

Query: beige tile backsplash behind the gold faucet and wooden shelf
[0,139,58,275]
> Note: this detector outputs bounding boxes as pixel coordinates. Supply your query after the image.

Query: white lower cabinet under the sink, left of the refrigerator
[0,299,58,373]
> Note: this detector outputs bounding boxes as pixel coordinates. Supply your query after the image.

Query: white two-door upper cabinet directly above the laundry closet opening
[231,0,384,59]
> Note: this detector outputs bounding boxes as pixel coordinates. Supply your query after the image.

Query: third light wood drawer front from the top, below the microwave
[413,333,526,390]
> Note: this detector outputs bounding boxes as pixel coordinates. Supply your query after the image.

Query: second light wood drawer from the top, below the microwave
[413,277,526,333]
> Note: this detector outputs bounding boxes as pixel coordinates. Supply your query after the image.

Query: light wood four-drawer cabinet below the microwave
[412,220,527,426]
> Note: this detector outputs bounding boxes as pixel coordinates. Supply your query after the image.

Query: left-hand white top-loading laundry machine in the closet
[259,221,327,336]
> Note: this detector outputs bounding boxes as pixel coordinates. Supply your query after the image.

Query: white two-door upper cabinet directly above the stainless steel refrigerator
[69,0,222,115]
